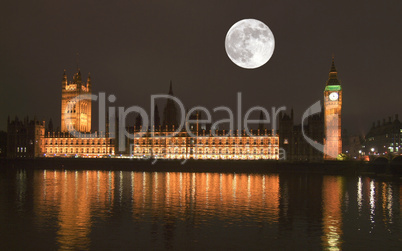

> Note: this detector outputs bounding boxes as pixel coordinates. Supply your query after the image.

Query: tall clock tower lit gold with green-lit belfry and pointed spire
[324,56,342,160]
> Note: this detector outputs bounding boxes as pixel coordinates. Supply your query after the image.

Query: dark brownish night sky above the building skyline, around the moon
[0,0,402,134]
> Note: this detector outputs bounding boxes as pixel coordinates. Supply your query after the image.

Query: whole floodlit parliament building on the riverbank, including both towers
[7,60,342,161]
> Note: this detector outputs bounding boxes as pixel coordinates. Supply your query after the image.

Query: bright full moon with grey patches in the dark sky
[225,19,275,69]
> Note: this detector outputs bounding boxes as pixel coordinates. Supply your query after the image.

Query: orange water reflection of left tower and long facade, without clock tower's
[34,170,280,250]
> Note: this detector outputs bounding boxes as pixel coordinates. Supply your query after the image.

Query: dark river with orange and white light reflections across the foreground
[0,169,402,250]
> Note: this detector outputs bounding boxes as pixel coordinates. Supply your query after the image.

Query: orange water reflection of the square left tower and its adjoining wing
[34,170,114,249]
